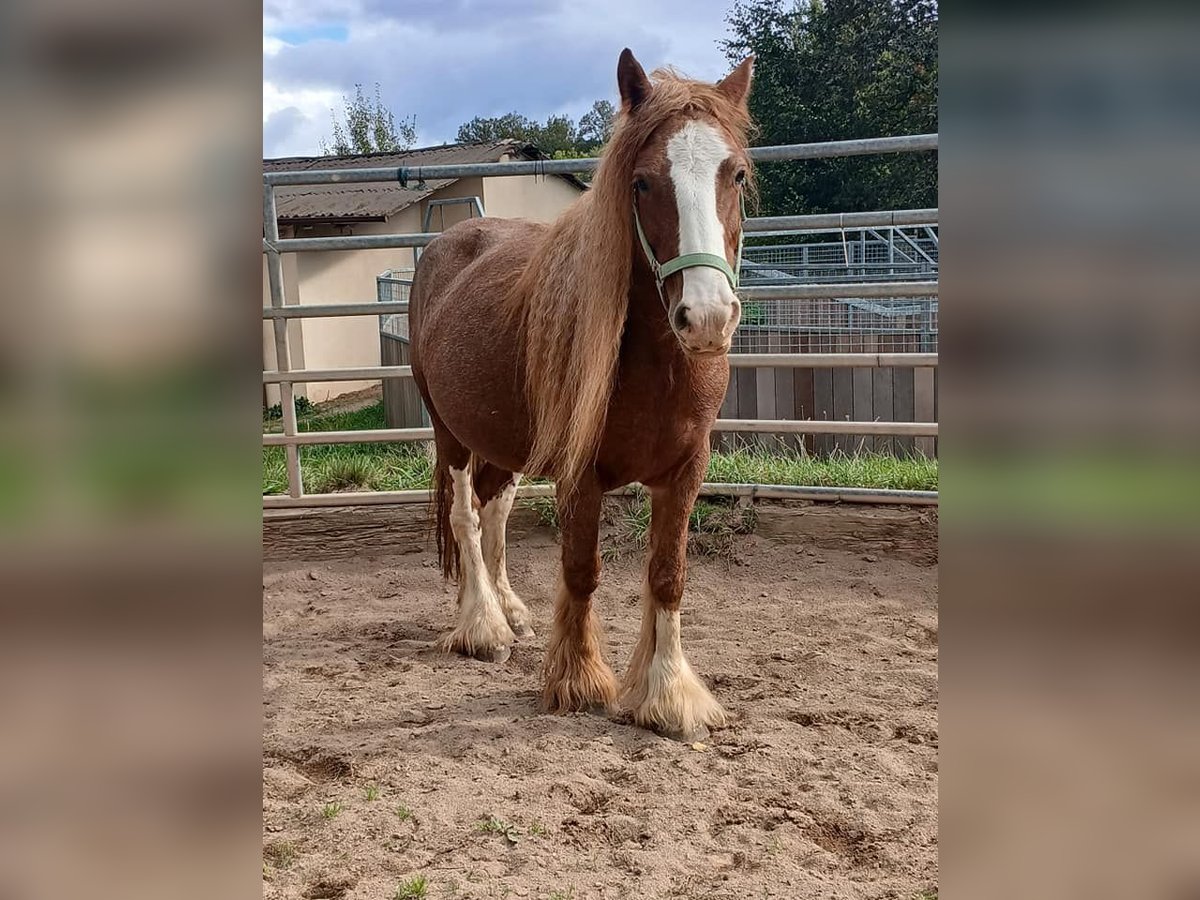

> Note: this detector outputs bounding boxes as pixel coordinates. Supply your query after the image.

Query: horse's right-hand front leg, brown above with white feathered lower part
[620,446,726,740]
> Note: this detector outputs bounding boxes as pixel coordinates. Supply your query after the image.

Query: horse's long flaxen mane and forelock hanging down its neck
[509,68,750,497]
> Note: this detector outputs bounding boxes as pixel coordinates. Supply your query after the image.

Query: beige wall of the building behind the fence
[263,175,580,406]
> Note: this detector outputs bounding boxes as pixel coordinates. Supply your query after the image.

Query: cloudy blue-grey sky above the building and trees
[263,0,732,157]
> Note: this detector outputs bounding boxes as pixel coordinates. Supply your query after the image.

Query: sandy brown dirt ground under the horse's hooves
[263,533,937,900]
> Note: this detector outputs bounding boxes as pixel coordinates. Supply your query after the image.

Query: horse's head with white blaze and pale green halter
[617,49,754,355]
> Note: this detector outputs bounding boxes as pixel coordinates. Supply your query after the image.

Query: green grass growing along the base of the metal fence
[263,403,937,496]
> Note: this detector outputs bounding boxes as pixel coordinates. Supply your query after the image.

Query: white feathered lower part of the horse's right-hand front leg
[625,586,726,740]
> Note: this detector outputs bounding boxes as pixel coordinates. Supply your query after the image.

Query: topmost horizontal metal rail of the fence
[263,134,937,186]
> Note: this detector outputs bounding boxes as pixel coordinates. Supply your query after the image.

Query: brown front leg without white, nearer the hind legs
[542,479,617,713]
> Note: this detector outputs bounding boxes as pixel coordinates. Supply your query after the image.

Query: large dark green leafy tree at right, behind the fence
[724,0,937,215]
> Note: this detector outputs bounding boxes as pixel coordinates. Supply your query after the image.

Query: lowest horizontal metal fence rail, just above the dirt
[263,481,937,510]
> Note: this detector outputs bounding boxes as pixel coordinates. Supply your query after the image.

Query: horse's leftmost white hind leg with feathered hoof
[442,468,514,662]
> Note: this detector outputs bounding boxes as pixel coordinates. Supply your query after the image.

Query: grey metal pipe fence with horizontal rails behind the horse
[263,134,937,509]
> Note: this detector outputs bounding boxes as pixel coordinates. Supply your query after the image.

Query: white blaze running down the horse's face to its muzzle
[667,119,734,330]
